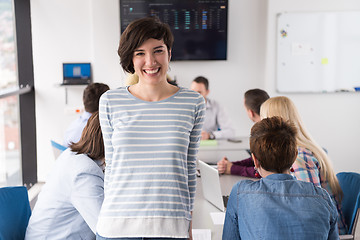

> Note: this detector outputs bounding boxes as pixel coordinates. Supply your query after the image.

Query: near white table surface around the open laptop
[192,175,254,240]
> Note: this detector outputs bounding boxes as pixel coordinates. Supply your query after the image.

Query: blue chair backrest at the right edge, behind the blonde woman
[336,172,360,234]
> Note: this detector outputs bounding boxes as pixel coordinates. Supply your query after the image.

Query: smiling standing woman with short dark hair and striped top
[97,17,205,239]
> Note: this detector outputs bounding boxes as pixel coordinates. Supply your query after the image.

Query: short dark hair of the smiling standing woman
[118,17,174,73]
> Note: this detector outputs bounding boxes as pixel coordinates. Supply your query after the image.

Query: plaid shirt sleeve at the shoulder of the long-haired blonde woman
[292,151,321,187]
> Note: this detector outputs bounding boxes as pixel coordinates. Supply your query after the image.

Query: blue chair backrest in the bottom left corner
[0,186,31,240]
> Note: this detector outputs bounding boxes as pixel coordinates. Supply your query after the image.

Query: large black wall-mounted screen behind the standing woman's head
[120,0,228,60]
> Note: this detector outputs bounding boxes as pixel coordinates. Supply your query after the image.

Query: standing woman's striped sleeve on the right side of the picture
[187,97,205,211]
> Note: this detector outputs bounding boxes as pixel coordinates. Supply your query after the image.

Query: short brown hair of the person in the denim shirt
[250,117,297,173]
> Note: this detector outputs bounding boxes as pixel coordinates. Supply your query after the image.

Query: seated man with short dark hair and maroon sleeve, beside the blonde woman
[217,89,269,178]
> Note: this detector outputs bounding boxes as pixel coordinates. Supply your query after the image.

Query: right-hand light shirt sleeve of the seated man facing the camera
[213,102,235,139]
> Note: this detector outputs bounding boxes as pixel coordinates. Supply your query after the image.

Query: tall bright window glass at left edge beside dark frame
[0,0,22,187]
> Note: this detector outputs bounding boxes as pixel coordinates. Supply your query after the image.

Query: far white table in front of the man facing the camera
[198,137,250,164]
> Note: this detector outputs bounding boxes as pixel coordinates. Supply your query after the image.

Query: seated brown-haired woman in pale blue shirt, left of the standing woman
[25,112,105,240]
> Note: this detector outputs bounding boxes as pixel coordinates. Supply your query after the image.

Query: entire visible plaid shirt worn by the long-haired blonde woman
[292,147,347,235]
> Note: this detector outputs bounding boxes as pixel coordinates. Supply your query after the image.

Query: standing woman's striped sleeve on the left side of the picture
[99,93,113,187]
